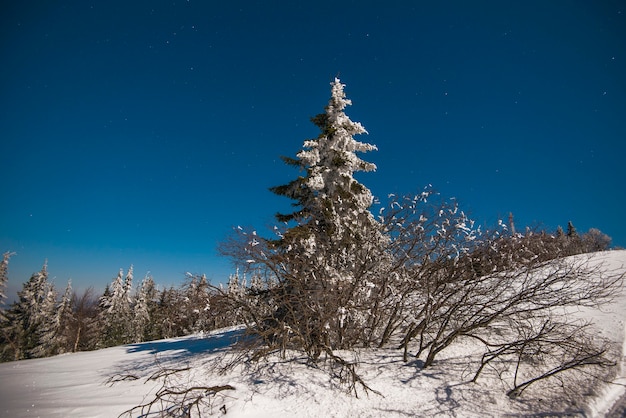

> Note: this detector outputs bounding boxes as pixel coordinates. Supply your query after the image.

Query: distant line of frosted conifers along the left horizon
[0,252,252,361]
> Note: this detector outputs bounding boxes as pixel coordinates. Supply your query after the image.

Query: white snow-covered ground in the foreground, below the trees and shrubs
[0,251,626,418]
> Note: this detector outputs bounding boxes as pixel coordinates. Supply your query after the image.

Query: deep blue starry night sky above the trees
[0,0,626,298]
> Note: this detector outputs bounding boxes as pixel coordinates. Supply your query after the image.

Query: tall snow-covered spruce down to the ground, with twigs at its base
[224,79,389,359]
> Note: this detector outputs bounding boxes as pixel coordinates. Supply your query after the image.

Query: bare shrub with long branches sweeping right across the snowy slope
[403,256,622,366]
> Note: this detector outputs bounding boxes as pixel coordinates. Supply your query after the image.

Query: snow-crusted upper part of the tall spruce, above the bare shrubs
[271,78,376,243]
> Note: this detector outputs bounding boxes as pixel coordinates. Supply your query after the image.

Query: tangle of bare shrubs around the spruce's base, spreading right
[217,190,623,402]
